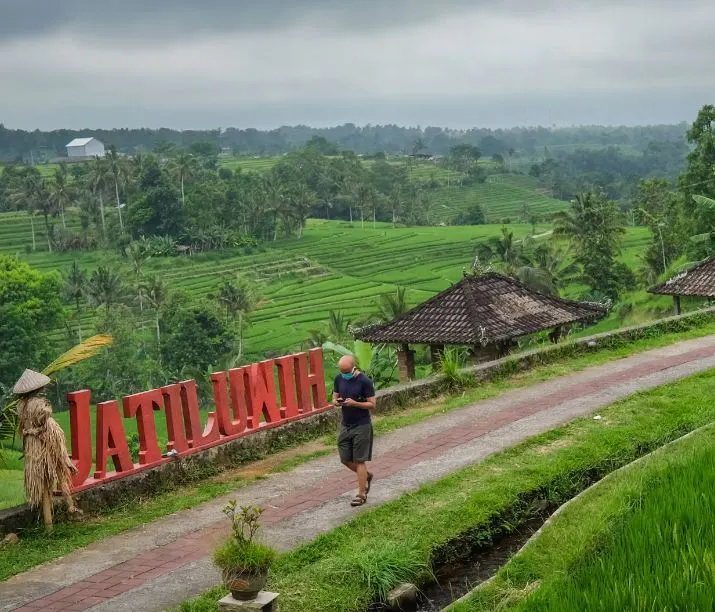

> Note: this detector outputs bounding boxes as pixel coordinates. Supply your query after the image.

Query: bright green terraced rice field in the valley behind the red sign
[0,201,649,355]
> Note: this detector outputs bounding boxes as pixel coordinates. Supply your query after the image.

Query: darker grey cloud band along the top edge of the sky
[0,0,672,40]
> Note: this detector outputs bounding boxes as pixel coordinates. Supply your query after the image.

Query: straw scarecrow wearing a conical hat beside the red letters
[13,370,81,528]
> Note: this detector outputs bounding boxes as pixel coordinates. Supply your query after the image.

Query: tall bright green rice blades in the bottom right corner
[516,432,715,612]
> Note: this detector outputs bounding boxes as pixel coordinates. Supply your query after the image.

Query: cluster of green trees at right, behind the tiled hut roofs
[473,105,715,310]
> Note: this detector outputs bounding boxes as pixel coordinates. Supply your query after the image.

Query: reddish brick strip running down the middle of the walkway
[0,337,715,611]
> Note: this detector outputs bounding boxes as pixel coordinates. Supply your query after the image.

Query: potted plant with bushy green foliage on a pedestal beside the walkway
[213,500,276,601]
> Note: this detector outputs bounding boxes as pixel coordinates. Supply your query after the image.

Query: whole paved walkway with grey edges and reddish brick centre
[0,336,715,612]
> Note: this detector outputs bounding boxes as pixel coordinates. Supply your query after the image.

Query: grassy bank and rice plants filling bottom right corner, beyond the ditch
[450,426,715,612]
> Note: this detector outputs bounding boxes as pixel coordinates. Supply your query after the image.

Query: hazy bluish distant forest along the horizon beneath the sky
[0,123,688,163]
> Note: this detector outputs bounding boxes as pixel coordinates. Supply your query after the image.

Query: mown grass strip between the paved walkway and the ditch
[180,372,715,612]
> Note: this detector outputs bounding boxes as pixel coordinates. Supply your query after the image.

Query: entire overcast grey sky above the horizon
[0,0,715,129]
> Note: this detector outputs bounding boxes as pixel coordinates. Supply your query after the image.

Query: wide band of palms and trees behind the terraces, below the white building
[0,138,498,254]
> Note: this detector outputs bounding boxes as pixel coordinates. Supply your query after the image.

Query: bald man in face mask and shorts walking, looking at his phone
[333,355,375,506]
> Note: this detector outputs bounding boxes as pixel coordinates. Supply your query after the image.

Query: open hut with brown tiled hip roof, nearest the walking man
[354,272,606,381]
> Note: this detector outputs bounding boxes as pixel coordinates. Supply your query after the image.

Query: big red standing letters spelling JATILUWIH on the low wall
[67,349,330,491]
